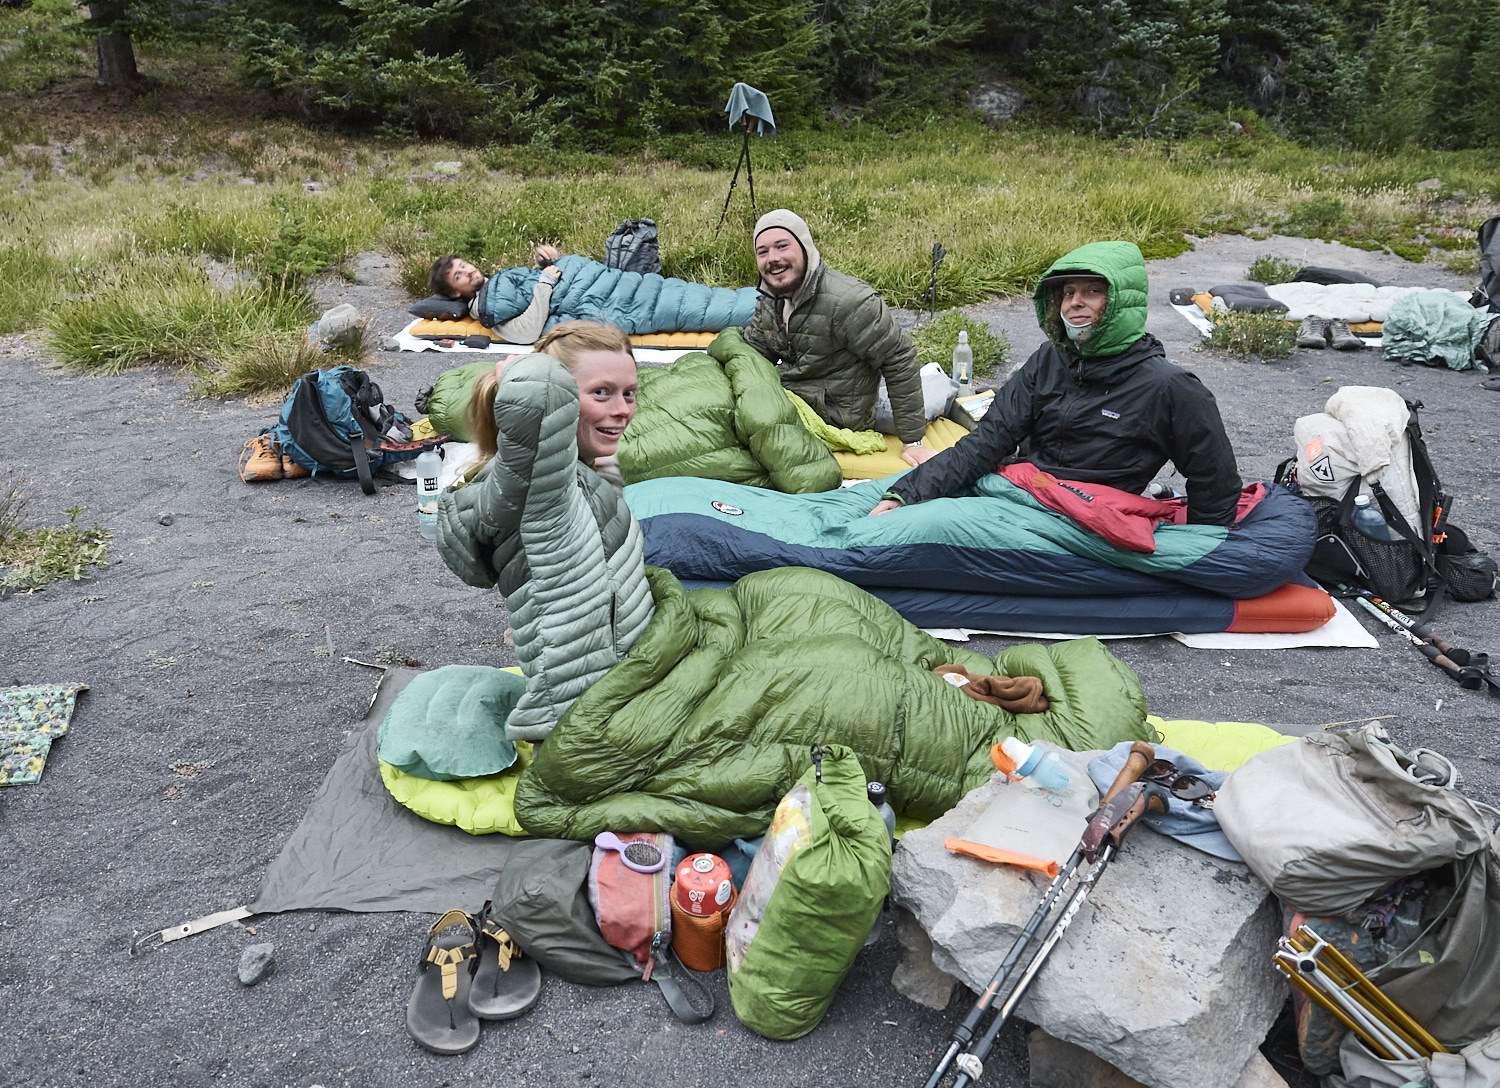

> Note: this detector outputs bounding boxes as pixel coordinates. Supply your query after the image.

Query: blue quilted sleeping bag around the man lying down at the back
[480,255,756,333]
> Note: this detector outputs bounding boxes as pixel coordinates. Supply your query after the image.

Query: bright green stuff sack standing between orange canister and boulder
[725,744,891,1038]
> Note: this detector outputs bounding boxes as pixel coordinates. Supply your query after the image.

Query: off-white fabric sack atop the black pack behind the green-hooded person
[1293,386,1421,528]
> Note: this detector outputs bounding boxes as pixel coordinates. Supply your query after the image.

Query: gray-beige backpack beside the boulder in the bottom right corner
[1214,722,1500,1046]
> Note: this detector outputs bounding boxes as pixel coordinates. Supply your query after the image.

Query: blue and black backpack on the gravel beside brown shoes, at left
[270,366,440,495]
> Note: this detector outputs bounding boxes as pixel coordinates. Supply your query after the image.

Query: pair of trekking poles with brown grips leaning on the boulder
[926,741,1176,1088]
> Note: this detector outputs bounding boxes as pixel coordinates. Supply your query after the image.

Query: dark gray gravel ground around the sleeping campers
[0,237,1500,1088]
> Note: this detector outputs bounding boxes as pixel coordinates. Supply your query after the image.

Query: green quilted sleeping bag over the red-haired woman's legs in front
[516,567,1152,846]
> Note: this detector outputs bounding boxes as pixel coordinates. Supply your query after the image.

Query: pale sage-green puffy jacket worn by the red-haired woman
[438,354,653,741]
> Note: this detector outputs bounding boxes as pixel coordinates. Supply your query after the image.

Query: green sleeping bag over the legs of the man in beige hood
[620,329,842,495]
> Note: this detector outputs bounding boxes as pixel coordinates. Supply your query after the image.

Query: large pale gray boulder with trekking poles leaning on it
[891,752,1287,1088]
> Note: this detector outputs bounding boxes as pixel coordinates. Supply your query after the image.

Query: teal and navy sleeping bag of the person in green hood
[626,474,1317,633]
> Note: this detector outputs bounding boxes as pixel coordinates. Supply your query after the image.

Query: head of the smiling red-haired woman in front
[468,321,638,465]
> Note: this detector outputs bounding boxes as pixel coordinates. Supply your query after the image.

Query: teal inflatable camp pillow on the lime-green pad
[375,665,527,782]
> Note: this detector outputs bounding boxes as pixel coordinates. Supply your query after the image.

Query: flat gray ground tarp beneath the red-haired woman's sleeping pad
[249,669,512,914]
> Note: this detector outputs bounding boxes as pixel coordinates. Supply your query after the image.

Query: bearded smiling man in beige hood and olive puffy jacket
[743,209,933,465]
